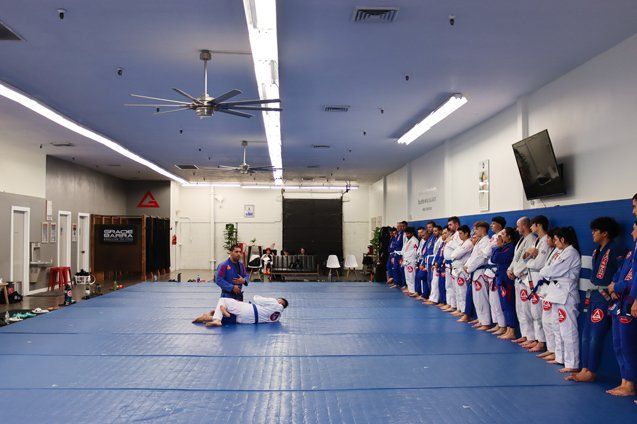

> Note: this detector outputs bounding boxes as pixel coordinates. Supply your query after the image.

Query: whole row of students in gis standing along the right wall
[387,194,637,402]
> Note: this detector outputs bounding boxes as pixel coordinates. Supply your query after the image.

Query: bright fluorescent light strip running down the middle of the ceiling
[243,0,283,185]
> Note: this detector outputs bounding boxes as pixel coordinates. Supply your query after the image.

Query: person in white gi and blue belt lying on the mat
[193,296,288,327]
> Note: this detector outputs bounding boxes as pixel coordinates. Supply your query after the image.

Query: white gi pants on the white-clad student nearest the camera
[552,293,579,369]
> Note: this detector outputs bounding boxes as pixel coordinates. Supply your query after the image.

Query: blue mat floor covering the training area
[0,283,637,423]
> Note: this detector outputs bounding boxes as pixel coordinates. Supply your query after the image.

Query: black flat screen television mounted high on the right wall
[513,130,566,200]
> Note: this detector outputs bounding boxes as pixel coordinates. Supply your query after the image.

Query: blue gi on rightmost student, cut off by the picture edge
[612,240,637,382]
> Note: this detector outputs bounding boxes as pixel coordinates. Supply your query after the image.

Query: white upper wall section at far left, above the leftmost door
[0,134,46,198]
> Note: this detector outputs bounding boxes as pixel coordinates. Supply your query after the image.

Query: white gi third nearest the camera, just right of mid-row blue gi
[509,233,537,340]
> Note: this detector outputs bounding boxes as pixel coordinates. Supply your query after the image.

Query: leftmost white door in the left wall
[9,206,31,296]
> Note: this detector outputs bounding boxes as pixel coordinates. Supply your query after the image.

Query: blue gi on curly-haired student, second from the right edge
[581,241,624,372]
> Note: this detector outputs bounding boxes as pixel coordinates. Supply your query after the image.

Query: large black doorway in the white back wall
[283,199,343,264]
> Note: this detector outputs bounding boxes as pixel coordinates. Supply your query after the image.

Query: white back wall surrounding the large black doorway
[171,185,370,269]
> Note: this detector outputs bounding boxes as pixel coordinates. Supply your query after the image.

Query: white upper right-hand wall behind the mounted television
[373,35,637,225]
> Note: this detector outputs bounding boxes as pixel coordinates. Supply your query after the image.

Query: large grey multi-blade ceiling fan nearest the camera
[125,50,281,118]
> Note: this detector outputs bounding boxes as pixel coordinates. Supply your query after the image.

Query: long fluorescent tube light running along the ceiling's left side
[0,82,187,184]
